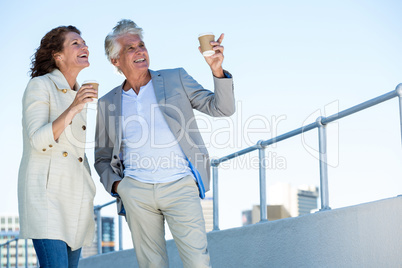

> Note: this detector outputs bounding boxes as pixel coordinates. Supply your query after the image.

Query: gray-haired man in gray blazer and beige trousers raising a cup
[95,20,235,267]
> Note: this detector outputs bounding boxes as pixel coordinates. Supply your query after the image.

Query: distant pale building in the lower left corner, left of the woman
[0,215,37,268]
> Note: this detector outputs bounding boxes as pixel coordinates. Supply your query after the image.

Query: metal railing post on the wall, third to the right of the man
[316,116,331,211]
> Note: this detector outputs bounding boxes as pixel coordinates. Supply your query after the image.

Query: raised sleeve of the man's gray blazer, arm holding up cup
[179,68,236,117]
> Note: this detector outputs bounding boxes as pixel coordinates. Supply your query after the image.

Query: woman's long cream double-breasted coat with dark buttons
[18,69,95,250]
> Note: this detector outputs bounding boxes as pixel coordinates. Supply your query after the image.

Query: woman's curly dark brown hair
[31,25,81,78]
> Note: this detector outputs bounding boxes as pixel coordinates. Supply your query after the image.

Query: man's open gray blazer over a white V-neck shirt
[95,68,235,214]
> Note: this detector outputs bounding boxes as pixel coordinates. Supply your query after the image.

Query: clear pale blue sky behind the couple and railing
[0,0,402,245]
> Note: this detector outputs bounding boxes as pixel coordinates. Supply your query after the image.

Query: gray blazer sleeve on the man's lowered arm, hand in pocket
[94,100,122,196]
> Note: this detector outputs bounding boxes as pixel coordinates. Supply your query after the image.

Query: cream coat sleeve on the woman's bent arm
[22,78,56,152]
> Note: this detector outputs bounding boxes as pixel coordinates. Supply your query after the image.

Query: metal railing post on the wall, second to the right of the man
[257,141,268,222]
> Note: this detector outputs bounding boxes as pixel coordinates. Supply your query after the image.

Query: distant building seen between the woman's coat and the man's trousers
[81,217,115,258]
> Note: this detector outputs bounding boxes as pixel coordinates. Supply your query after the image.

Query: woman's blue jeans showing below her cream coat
[32,239,81,268]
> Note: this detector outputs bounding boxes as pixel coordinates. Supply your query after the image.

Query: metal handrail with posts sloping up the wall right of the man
[211,83,402,231]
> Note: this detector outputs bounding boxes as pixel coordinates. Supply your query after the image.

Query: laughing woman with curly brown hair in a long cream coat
[18,26,96,268]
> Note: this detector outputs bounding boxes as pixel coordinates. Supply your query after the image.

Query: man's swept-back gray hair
[105,19,143,63]
